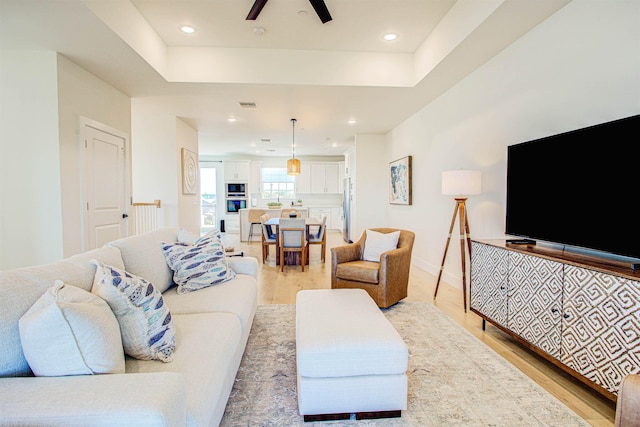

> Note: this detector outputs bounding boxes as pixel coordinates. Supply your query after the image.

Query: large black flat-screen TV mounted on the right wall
[505,115,640,258]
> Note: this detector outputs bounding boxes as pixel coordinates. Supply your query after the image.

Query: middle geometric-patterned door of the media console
[508,251,563,359]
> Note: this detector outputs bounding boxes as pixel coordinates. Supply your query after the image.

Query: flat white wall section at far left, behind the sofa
[0,50,63,270]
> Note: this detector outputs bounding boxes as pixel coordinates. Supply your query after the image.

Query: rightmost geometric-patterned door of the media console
[561,265,640,394]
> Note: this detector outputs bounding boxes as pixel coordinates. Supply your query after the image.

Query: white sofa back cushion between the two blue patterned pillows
[107,227,178,292]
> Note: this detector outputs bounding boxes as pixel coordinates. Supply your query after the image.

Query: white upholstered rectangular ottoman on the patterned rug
[296,289,409,421]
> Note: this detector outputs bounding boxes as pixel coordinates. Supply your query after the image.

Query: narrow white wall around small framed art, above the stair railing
[176,119,200,234]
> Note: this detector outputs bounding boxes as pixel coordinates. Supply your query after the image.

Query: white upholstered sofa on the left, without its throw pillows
[0,228,258,427]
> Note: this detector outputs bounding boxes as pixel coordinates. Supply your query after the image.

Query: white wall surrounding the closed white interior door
[58,55,133,257]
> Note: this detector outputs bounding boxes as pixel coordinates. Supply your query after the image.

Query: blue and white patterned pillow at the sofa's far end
[162,235,236,294]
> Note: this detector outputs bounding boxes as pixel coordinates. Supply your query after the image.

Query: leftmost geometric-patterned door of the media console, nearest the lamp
[469,242,508,327]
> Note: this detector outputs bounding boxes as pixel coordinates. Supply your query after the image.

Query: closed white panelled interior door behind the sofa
[84,125,128,249]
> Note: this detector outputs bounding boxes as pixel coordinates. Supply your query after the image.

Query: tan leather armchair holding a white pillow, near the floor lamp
[331,228,415,308]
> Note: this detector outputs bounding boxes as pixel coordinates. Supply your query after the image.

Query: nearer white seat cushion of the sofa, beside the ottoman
[125,312,245,426]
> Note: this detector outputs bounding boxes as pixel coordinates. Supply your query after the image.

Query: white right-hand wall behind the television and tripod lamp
[384,0,640,287]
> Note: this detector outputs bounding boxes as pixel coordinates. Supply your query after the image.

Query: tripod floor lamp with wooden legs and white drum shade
[433,170,482,313]
